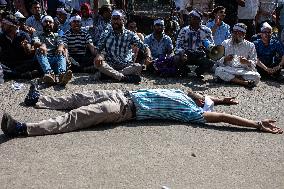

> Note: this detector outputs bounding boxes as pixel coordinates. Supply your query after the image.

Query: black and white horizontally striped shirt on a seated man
[62,29,93,55]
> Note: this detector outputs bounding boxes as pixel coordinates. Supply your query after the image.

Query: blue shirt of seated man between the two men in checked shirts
[144,33,173,59]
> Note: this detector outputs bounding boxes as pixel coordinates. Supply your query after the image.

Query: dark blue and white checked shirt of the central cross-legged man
[97,28,147,69]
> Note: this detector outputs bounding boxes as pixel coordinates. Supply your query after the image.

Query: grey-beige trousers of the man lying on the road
[26,90,133,136]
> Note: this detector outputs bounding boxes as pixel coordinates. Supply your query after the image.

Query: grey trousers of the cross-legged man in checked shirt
[95,61,143,81]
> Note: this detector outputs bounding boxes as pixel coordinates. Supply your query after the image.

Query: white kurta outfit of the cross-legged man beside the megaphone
[215,39,260,84]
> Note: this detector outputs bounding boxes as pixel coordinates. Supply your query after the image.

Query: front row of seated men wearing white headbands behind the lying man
[0,9,284,87]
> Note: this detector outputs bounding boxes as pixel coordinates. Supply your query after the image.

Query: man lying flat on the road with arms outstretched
[1,86,283,137]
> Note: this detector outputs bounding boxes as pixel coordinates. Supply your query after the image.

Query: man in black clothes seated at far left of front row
[0,14,39,79]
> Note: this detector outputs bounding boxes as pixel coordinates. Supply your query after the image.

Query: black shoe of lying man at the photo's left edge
[1,113,27,137]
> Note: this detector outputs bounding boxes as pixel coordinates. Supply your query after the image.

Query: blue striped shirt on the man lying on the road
[129,89,205,123]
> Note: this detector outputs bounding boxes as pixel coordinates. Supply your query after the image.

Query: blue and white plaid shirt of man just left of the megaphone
[176,25,214,53]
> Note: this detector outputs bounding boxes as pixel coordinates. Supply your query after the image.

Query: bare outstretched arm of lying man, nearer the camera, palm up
[203,112,283,134]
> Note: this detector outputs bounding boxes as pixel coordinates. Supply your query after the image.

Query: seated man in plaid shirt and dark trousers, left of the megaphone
[176,10,215,79]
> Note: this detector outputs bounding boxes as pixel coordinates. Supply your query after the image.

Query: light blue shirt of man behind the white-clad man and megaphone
[206,20,231,45]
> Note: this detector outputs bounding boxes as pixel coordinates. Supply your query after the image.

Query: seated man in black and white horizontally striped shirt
[62,15,95,72]
